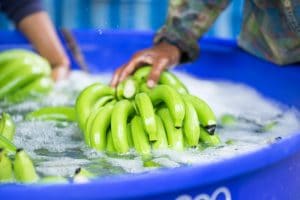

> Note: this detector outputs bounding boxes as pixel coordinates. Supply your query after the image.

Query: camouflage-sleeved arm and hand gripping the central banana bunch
[111,0,230,87]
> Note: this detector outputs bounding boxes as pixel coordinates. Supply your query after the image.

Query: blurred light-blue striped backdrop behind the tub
[0,0,243,39]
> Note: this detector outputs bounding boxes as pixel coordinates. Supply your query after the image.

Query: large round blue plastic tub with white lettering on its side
[0,30,300,200]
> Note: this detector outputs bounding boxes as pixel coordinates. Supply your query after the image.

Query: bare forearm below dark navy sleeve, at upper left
[17,11,70,67]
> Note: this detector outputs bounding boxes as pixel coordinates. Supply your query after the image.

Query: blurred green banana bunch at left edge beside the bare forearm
[0,49,53,103]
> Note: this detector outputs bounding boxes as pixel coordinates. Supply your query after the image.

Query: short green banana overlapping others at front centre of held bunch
[135,92,157,141]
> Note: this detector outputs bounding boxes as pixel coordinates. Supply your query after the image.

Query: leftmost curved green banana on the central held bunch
[75,83,115,130]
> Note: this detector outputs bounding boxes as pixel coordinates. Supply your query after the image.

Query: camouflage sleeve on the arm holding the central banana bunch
[154,0,230,62]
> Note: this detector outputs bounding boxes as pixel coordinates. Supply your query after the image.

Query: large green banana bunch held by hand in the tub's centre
[75,67,220,155]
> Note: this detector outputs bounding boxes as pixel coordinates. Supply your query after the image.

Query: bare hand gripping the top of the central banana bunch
[111,42,180,88]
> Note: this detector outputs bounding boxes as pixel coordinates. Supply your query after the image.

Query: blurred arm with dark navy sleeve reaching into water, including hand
[0,0,70,80]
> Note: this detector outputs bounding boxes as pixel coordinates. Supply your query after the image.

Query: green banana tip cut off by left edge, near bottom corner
[0,149,14,183]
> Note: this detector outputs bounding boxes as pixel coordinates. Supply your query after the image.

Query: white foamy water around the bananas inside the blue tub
[0,71,300,180]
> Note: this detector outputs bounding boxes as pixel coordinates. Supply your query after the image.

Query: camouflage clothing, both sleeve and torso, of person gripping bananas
[154,0,300,65]
